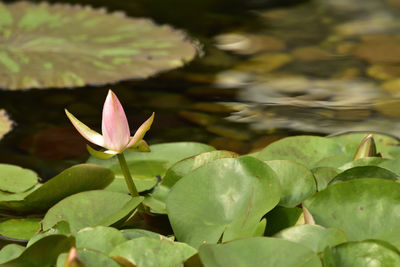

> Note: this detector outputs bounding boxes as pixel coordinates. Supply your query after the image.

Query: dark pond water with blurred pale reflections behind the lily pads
[0,0,400,177]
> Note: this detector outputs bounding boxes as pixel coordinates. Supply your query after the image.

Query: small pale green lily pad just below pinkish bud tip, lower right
[275,224,347,253]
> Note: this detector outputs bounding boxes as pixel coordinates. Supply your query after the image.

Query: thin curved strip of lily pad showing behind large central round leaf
[143,150,239,214]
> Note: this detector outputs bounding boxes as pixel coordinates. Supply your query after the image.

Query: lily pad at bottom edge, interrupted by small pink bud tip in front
[56,249,121,267]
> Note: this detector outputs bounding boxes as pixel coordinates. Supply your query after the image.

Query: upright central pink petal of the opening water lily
[102,90,130,152]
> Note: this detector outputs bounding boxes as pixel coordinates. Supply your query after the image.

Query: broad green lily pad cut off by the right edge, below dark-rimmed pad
[304,178,400,241]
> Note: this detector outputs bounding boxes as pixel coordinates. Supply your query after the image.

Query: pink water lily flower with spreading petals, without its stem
[65,90,154,159]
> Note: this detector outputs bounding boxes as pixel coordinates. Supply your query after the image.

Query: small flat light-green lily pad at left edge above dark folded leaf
[0,164,38,193]
